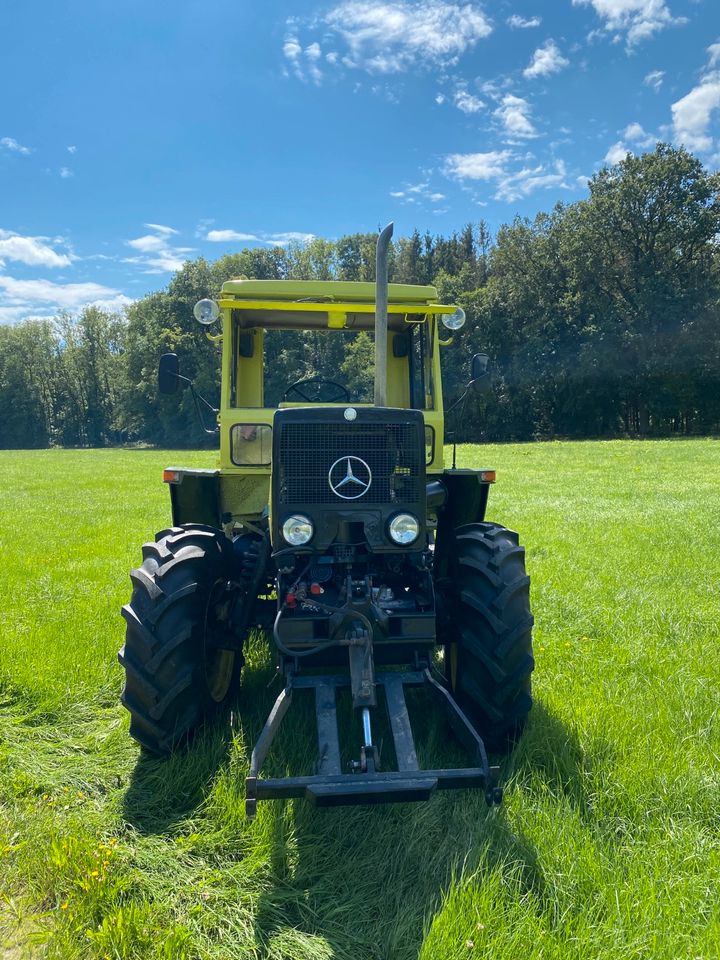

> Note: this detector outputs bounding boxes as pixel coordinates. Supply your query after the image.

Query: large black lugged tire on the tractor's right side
[445,523,535,752]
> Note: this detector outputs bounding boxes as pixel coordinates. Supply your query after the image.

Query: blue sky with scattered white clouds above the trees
[0,0,720,323]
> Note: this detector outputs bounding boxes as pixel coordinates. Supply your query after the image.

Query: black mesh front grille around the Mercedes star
[274,423,425,507]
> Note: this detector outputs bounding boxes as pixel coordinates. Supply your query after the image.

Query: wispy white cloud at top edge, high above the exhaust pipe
[290,0,492,76]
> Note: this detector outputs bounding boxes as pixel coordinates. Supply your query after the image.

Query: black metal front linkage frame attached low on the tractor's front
[245,663,502,819]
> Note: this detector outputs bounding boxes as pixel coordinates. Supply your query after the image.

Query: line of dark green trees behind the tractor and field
[0,144,720,448]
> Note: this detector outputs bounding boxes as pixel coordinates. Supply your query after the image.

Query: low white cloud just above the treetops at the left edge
[0,274,132,320]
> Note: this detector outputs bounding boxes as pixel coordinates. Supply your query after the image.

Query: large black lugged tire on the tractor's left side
[118,524,243,754]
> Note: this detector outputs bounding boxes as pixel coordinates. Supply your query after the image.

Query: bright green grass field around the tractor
[0,441,720,960]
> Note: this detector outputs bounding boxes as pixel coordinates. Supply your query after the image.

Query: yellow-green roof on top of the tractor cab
[220,279,455,330]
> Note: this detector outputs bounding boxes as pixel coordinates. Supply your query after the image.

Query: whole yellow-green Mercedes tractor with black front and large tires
[119,224,534,817]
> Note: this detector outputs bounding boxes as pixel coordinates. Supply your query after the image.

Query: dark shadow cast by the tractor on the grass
[123,645,603,960]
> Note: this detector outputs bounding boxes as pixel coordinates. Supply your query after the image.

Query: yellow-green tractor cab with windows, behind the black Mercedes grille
[211,280,464,471]
